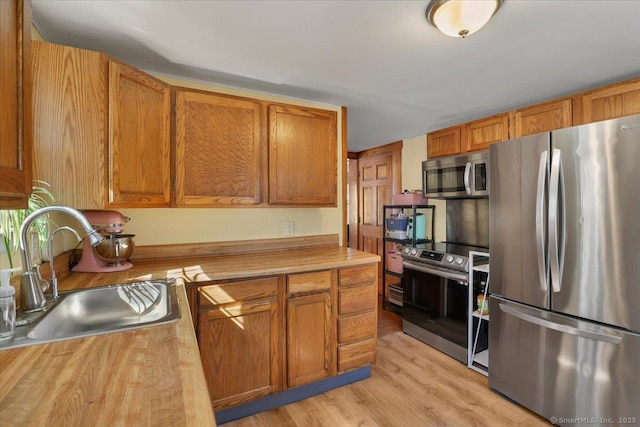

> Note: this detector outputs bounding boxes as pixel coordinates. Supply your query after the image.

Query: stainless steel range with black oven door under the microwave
[402,243,487,363]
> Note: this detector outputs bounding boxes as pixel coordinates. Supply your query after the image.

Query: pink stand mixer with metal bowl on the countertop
[71,210,135,273]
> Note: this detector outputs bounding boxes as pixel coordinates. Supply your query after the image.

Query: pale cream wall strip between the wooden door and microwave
[402,134,447,242]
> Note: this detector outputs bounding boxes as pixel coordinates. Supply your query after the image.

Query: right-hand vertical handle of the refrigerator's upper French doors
[549,148,566,292]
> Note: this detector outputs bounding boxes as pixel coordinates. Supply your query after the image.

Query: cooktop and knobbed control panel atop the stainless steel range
[402,242,488,271]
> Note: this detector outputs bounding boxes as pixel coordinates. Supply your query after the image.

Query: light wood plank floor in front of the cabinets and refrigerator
[224,302,549,427]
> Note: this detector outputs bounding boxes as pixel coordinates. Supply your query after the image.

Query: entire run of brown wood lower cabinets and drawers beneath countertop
[192,263,378,411]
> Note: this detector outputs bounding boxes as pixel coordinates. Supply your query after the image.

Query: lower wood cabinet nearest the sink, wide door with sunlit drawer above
[197,277,283,410]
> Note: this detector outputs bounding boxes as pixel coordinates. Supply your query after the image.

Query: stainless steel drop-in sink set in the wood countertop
[0,279,180,349]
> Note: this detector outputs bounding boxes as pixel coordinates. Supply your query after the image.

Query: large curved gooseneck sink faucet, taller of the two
[20,206,104,311]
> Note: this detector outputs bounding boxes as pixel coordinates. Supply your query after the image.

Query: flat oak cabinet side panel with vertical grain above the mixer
[32,41,109,209]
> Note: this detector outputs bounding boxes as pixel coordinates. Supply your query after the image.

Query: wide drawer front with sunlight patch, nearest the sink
[198,277,278,308]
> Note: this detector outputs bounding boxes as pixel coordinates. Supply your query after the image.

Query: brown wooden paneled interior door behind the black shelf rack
[358,154,393,294]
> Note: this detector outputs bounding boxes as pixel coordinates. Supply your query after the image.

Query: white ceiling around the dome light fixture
[32,0,640,151]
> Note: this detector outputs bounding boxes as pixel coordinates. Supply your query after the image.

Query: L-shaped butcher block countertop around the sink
[0,237,380,426]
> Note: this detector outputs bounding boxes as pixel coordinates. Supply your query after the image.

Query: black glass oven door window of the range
[402,267,469,348]
